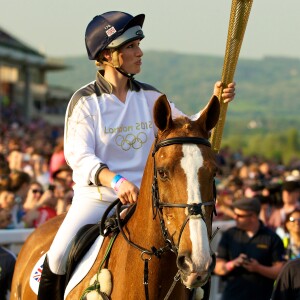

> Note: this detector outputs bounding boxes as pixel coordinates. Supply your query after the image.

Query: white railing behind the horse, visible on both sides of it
[0,220,235,300]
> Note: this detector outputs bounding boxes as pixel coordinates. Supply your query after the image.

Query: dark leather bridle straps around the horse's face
[152,137,216,254]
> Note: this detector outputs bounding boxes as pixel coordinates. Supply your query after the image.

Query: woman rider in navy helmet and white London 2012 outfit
[38,11,235,300]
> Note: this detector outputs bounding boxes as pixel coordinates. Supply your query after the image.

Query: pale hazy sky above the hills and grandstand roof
[0,0,300,59]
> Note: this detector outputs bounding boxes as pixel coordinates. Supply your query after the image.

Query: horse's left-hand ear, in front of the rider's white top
[153,95,173,131]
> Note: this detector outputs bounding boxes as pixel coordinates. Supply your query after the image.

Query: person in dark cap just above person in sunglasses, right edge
[267,180,300,237]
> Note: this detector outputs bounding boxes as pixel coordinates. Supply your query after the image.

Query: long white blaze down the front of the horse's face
[181,144,211,271]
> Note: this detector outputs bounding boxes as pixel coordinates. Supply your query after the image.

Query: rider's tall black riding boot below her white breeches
[38,256,66,300]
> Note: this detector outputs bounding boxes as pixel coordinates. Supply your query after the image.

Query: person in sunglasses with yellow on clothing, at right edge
[283,208,300,260]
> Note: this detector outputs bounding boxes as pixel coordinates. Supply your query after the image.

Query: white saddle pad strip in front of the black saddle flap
[64,235,103,299]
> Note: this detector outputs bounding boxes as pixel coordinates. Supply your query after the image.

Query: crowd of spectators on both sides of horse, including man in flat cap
[0,111,300,300]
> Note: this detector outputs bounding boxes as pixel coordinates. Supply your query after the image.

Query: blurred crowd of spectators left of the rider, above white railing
[0,117,73,229]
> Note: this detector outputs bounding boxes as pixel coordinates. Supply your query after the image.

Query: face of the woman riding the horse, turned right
[119,40,143,74]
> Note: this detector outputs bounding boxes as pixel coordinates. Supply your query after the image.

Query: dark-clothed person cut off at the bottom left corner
[0,246,16,300]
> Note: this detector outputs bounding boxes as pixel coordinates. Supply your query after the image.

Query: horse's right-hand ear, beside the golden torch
[198,95,220,131]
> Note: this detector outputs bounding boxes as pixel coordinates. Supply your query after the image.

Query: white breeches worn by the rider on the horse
[47,187,117,275]
